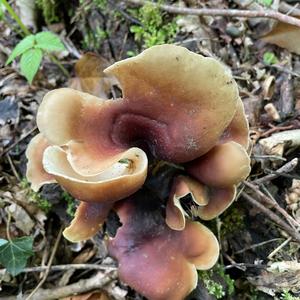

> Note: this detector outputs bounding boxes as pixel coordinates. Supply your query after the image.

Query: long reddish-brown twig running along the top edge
[126,0,300,27]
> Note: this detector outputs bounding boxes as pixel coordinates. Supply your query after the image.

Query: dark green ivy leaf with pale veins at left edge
[0,236,33,276]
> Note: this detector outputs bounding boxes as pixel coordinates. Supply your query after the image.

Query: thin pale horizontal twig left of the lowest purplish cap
[0,264,117,275]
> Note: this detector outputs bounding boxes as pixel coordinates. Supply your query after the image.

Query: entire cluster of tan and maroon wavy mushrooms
[26,45,250,300]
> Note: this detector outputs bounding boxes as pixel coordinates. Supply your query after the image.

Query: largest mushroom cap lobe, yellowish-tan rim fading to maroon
[104,45,239,163]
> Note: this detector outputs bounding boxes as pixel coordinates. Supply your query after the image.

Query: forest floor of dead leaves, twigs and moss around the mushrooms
[0,0,300,300]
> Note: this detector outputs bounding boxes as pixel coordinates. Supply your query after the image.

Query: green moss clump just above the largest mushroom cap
[130,3,177,48]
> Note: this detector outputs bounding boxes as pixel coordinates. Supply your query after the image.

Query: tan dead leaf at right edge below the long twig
[261,22,300,54]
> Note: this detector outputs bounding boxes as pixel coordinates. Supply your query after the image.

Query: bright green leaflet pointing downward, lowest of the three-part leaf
[20,48,43,83]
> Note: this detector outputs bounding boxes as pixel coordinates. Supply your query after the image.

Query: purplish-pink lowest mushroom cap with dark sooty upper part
[109,199,219,300]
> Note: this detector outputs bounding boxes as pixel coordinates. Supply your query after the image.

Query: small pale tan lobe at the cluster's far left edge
[26,134,55,191]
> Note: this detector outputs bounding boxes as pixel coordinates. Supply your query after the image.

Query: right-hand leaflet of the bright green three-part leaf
[35,31,66,52]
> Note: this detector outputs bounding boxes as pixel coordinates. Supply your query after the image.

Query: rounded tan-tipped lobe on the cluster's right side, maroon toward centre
[187,142,251,187]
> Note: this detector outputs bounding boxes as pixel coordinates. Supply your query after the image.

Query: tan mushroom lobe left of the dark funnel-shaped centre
[37,88,128,176]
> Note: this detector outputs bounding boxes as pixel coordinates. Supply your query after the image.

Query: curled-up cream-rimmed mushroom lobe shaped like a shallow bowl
[43,146,148,203]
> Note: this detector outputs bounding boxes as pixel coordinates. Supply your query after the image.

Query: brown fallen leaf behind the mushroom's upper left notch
[70,52,118,99]
